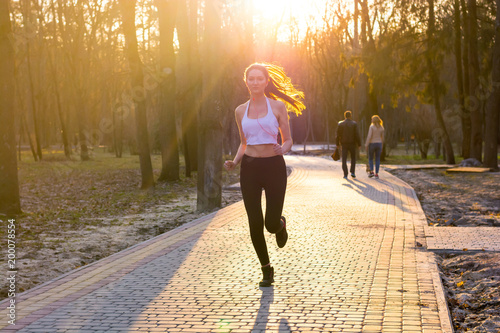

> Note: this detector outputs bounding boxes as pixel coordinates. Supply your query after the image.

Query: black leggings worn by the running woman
[240,155,287,266]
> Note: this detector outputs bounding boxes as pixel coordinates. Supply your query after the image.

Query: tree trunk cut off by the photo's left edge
[0,1,21,215]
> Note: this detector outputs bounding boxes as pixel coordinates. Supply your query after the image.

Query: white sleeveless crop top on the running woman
[241,97,279,146]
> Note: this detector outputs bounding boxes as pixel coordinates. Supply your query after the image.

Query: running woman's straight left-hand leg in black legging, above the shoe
[240,155,269,266]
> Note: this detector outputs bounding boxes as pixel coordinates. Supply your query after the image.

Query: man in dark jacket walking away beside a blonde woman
[336,111,361,179]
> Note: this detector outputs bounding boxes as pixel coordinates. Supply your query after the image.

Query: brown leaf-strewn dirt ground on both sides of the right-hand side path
[392,169,500,333]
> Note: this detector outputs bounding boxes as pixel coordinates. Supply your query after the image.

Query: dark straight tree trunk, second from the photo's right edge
[467,0,483,161]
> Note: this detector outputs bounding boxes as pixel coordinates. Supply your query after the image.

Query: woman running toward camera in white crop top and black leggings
[224,63,305,287]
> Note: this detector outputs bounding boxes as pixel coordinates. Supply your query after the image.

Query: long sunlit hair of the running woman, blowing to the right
[243,62,306,116]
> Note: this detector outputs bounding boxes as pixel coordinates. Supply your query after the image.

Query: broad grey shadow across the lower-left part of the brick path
[4,209,230,332]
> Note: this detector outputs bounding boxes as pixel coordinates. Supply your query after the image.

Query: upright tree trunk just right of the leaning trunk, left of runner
[156,0,179,181]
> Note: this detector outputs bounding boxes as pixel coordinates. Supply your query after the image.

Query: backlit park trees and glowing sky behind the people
[0,0,500,213]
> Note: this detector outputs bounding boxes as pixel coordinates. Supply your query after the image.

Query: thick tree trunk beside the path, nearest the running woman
[197,0,223,211]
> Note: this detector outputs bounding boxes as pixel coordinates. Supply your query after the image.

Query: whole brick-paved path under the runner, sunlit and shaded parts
[0,156,460,333]
